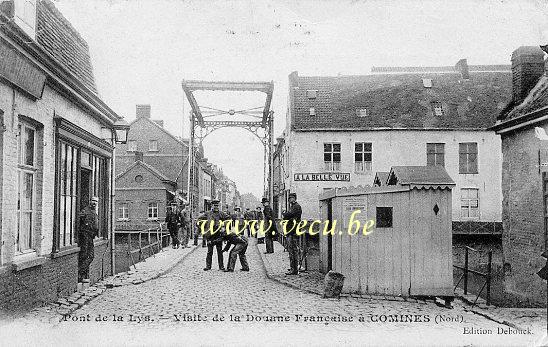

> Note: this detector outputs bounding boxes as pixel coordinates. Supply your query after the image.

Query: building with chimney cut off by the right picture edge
[493,47,548,305]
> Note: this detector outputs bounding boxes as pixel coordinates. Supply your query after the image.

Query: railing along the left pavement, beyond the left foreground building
[115,223,169,269]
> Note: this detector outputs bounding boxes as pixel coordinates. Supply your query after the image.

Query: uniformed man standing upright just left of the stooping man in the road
[197,200,230,271]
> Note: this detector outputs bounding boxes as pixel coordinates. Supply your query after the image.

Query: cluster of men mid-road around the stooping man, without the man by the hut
[197,198,278,272]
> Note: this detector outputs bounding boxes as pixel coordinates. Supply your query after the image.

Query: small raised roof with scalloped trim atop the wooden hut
[388,166,455,186]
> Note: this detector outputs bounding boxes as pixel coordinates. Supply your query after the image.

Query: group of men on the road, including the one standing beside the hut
[197,193,302,275]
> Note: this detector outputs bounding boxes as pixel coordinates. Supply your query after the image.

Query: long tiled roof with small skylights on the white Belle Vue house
[289,69,512,131]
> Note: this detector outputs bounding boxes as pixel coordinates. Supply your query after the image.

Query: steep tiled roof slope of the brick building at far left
[36,0,97,94]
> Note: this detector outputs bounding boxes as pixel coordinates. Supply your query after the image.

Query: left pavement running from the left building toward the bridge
[12,241,201,324]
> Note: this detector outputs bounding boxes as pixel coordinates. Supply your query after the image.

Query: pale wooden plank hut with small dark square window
[319,166,455,296]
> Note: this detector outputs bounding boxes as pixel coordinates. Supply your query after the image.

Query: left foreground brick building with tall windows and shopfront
[0,0,121,311]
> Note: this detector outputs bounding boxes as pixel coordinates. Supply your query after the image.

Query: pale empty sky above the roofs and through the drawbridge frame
[54,0,548,197]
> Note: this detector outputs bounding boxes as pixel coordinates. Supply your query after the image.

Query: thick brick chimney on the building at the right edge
[512,46,544,103]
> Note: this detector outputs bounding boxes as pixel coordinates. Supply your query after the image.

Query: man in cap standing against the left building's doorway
[78,196,99,282]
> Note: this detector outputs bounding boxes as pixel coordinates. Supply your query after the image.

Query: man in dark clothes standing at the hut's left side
[282,193,303,275]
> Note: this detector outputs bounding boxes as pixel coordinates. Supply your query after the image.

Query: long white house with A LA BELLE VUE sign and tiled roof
[283,59,511,237]
